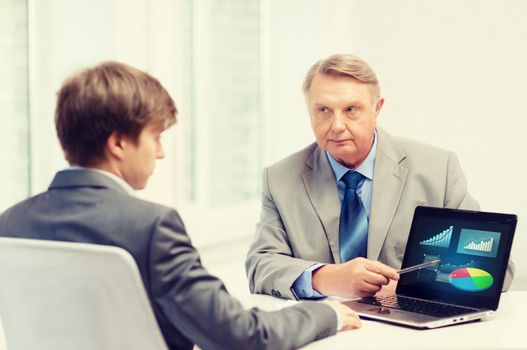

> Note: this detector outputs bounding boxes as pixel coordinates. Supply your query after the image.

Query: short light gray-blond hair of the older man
[302,54,381,98]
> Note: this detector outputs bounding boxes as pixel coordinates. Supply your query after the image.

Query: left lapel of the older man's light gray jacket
[302,147,340,262]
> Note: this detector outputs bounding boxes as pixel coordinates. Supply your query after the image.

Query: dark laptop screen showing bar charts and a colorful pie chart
[396,207,517,310]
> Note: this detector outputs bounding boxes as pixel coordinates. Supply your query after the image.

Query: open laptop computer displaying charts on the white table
[345,206,517,328]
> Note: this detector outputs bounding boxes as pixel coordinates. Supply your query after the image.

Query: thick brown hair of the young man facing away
[55,62,177,166]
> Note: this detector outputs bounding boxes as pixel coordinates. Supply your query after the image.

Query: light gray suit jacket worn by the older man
[245,128,514,298]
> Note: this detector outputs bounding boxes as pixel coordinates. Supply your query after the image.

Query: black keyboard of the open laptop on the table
[359,295,477,317]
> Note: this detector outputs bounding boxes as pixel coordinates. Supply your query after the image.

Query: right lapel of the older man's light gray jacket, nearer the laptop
[368,128,408,260]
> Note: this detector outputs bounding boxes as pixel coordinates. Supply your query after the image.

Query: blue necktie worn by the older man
[339,171,368,263]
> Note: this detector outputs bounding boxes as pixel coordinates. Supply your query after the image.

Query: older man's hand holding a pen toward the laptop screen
[312,258,399,298]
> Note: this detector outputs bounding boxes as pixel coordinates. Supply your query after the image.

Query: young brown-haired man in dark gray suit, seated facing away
[0,62,360,349]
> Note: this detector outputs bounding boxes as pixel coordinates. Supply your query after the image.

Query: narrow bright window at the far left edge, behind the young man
[0,0,30,211]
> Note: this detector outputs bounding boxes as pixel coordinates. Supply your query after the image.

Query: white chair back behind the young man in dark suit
[0,237,167,350]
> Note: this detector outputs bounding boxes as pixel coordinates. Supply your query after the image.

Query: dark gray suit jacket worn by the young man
[0,170,337,349]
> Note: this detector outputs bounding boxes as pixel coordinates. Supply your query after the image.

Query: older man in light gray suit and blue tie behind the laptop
[246,55,514,298]
